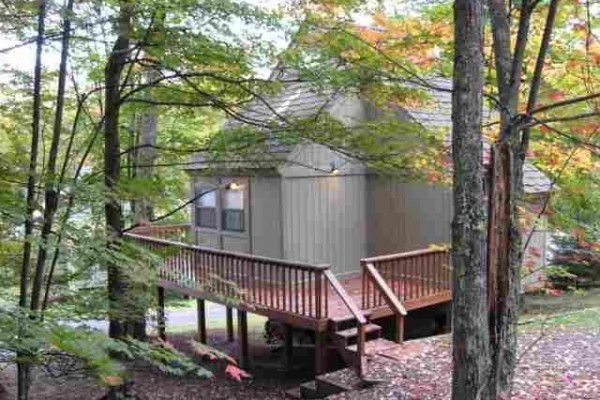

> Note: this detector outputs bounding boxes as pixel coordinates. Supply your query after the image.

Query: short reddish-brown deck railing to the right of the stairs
[361,249,450,310]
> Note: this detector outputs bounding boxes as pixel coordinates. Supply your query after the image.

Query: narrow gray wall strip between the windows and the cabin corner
[249,176,283,258]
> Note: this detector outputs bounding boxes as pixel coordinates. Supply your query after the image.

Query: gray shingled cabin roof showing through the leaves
[187,75,553,194]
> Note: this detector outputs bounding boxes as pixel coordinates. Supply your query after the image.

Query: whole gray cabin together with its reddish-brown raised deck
[125,76,552,382]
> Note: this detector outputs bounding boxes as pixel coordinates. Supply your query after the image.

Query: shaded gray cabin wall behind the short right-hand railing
[367,176,452,255]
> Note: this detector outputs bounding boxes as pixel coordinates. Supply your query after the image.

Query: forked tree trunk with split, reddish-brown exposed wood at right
[488,0,559,399]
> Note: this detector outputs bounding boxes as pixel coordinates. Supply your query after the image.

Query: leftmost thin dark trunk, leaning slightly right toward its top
[17,0,46,400]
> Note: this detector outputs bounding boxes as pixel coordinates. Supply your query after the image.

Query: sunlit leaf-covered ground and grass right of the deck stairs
[331,289,600,400]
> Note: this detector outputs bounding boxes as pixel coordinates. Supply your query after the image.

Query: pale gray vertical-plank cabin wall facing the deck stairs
[282,175,367,274]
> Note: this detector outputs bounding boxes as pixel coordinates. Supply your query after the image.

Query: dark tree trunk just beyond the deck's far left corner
[104,1,132,338]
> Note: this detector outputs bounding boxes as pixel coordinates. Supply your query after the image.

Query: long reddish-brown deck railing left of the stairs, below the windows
[125,234,336,320]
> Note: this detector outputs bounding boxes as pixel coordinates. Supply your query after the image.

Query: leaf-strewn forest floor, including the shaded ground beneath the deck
[0,289,600,400]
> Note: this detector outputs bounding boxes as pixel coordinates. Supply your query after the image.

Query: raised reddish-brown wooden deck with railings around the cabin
[125,225,450,376]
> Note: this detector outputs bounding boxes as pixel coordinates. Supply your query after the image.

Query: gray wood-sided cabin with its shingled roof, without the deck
[187,79,551,276]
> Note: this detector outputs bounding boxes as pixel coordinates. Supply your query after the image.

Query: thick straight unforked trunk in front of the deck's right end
[452,0,489,400]
